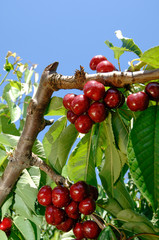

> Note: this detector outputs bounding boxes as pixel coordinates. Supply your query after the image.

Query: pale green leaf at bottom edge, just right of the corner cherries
[14,216,36,240]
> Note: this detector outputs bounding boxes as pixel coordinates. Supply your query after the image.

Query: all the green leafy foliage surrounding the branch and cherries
[0,31,159,240]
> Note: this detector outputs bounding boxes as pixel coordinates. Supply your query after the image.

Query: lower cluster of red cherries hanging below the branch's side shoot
[37,181,100,240]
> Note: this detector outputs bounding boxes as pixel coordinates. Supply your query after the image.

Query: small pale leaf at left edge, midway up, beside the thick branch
[0,133,19,147]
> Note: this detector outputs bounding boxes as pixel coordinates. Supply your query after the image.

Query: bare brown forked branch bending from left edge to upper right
[0,62,159,206]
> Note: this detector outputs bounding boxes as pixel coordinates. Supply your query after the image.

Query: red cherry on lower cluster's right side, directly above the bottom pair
[79,197,96,215]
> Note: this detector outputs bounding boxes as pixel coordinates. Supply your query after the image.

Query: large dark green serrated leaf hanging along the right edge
[128,106,159,209]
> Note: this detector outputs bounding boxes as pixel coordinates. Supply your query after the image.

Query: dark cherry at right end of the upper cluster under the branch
[104,88,122,108]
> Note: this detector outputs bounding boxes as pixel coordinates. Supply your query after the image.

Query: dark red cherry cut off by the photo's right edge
[145,82,159,101]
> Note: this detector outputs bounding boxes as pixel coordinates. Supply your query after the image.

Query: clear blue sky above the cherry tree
[0,0,159,139]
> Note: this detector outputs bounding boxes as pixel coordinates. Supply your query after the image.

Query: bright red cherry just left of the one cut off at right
[127,92,149,112]
